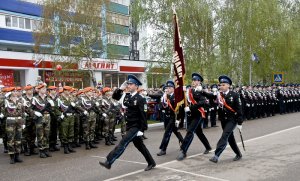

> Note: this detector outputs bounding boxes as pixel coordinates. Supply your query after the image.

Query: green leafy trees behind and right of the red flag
[132,0,300,84]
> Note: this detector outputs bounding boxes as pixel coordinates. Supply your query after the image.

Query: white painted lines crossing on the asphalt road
[101,126,300,181]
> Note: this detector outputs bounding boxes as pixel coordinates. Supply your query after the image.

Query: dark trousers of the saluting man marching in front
[106,127,155,165]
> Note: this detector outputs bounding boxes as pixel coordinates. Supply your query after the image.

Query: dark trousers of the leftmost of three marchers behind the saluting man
[159,120,183,151]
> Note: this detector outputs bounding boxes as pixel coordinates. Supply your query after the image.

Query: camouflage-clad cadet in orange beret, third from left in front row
[32,83,54,158]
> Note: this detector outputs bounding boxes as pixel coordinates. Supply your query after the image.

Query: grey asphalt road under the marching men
[0,113,300,181]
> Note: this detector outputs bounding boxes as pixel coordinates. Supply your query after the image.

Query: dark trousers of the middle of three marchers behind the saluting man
[181,117,211,153]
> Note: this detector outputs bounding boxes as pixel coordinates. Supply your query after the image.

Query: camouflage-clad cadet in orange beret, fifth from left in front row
[57,86,76,154]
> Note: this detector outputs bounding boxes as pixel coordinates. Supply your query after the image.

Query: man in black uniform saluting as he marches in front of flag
[99,75,156,171]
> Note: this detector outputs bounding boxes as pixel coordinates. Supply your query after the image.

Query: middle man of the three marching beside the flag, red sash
[176,73,216,161]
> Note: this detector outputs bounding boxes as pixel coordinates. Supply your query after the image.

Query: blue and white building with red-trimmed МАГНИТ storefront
[0,0,147,88]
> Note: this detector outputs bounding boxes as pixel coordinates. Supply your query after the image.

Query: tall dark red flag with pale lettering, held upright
[172,11,185,111]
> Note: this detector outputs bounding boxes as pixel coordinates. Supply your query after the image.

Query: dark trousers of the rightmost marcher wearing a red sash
[215,119,242,157]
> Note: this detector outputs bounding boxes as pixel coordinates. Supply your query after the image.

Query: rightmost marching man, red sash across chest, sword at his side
[209,75,243,163]
